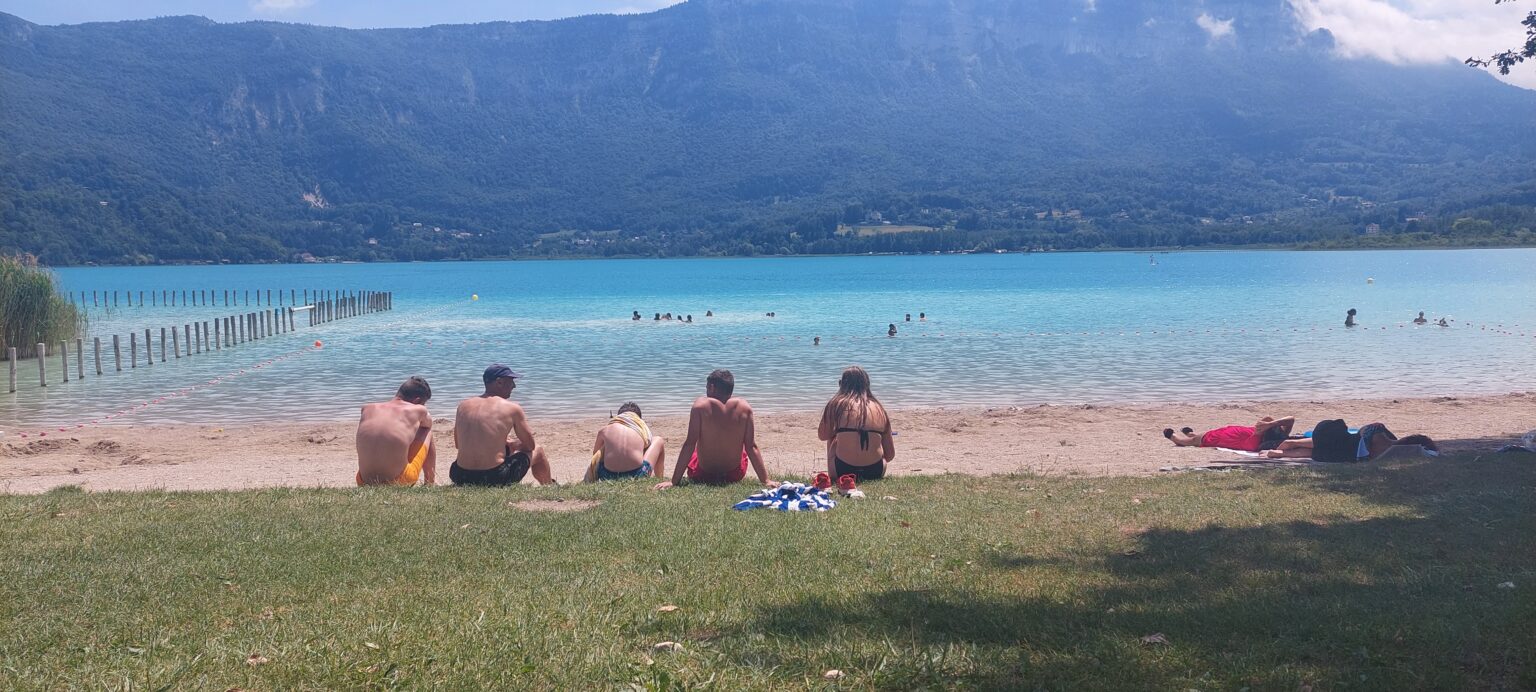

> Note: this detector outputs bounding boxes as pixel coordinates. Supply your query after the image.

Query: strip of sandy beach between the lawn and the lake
[0,393,1536,493]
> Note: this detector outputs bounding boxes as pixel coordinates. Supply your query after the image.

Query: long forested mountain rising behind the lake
[0,0,1536,264]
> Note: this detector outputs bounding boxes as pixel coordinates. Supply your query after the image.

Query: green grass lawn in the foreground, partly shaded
[0,457,1536,690]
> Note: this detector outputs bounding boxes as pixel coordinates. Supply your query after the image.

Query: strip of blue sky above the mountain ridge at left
[0,0,677,29]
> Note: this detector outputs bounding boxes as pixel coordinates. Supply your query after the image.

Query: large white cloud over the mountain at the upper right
[1290,0,1536,89]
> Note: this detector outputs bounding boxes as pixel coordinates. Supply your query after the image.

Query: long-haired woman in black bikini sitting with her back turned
[816,365,895,480]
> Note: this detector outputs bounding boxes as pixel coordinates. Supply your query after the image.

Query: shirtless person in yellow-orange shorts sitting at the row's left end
[356,377,438,485]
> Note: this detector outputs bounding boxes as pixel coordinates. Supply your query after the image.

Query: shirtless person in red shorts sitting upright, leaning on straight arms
[656,370,774,489]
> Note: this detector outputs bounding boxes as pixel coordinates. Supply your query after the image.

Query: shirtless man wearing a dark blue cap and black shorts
[449,364,554,486]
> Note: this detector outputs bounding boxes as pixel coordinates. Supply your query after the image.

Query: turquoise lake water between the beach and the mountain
[0,250,1536,431]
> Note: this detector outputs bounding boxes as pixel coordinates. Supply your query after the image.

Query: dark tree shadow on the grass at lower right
[745,460,1536,689]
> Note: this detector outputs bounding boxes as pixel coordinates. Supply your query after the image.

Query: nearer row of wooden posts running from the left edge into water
[6,292,395,391]
